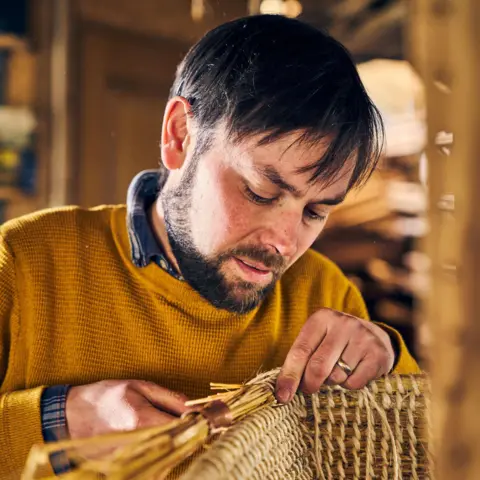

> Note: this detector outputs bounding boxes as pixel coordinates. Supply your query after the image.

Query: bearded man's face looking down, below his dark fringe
[161,127,351,313]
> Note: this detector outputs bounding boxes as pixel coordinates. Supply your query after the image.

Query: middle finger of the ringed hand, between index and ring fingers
[300,328,350,395]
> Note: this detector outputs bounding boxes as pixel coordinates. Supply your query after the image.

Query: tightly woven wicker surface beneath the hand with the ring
[182,376,430,480]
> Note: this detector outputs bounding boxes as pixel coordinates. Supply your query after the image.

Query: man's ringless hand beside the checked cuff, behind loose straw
[66,380,187,439]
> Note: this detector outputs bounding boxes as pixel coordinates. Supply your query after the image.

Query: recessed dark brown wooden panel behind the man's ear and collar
[75,24,188,206]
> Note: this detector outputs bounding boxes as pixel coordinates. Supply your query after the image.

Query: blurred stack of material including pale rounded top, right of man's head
[314,60,429,357]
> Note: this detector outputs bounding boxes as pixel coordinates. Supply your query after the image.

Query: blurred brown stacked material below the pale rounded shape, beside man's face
[314,157,429,354]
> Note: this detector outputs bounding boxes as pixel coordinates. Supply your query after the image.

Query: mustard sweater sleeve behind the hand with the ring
[343,284,421,374]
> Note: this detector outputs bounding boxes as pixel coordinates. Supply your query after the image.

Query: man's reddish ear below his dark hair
[161,97,193,170]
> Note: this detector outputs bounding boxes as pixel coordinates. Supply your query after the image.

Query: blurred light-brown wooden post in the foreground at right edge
[411,0,480,480]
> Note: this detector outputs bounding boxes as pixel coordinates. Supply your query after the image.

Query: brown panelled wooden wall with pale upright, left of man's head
[44,0,246,206]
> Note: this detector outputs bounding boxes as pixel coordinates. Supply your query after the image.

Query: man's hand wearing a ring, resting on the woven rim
[276,308,395,403]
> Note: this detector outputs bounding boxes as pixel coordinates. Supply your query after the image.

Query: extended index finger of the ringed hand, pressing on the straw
[275,317,327,403]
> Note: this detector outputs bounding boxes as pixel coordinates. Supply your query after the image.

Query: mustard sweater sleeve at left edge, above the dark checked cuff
[0,230,49,478]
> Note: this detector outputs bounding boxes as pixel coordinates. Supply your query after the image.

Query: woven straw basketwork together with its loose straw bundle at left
[23,370,429,480]
